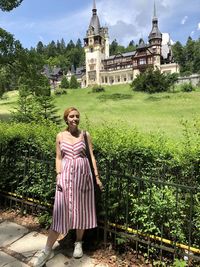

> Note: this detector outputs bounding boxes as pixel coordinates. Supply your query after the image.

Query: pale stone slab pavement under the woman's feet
[0,221,107,267]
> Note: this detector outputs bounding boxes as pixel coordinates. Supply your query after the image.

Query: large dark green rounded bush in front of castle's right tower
[131,68,178,93]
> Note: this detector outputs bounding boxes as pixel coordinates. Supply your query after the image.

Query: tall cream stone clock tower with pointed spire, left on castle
[84,0,109,86]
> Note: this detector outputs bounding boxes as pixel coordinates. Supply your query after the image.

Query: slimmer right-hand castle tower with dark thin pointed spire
[148,2,162,68]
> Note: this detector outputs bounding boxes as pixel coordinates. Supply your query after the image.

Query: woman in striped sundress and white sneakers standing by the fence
[34,107,102,267]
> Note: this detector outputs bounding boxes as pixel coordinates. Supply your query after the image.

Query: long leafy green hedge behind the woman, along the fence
[0,121,200,249]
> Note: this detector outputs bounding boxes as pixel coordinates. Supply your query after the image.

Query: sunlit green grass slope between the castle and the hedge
[0,85,200,139]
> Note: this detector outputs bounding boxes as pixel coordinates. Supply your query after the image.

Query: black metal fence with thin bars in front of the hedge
[0,148,200,262]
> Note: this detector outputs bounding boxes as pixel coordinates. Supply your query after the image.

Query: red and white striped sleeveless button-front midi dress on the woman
[51,140,97,234]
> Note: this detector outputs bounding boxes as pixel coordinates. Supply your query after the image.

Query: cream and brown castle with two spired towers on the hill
[76,0,179,87]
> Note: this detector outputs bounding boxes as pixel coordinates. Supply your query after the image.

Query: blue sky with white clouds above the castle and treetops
[0,0,200,48]
